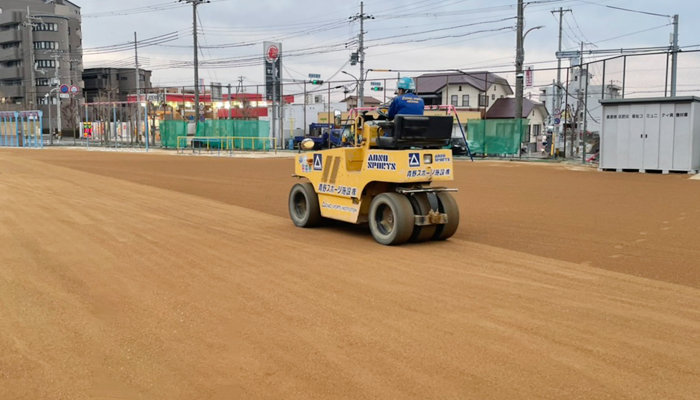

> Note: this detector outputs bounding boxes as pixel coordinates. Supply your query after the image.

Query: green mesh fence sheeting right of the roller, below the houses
[467,119,530,155]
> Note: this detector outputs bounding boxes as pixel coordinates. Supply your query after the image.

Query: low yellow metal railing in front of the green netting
[176,136,277,154]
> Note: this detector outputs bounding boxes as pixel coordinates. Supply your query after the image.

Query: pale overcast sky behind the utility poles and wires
[76,0,700,99]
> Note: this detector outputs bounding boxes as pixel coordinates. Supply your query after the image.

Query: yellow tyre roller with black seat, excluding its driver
[289,109,459,245]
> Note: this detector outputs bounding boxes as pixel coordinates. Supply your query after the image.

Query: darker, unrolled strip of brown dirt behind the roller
[8,149,700,288]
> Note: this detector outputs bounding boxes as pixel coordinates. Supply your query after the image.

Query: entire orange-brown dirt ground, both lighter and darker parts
[0,149,700,400]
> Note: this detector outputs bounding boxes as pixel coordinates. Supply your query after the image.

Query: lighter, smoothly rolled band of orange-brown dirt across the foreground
[0,153,700,399]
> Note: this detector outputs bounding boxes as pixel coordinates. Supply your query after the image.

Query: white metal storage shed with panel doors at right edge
[600,97,700,173]
